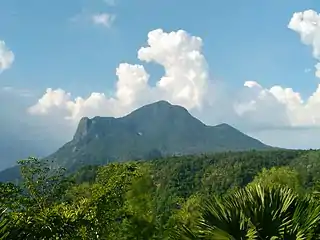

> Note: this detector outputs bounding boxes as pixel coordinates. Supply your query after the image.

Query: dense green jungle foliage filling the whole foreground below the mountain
[0,150,320,240]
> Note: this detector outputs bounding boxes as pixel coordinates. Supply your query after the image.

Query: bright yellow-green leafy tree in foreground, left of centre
[70,163,145,239]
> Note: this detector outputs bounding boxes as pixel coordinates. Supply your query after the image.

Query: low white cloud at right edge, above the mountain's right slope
[234,81,320,127]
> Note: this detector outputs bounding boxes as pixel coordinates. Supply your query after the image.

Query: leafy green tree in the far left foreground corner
[0,158,74,240]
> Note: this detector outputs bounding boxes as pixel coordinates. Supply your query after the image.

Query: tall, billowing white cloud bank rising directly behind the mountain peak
[29,29,210,122]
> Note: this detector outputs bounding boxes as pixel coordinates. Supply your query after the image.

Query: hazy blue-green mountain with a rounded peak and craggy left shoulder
[0,101,271,181]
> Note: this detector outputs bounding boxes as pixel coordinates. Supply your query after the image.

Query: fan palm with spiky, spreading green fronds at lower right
[174,184,320,240]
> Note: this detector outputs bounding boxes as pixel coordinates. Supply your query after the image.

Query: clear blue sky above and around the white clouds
[0,0,320,95]
